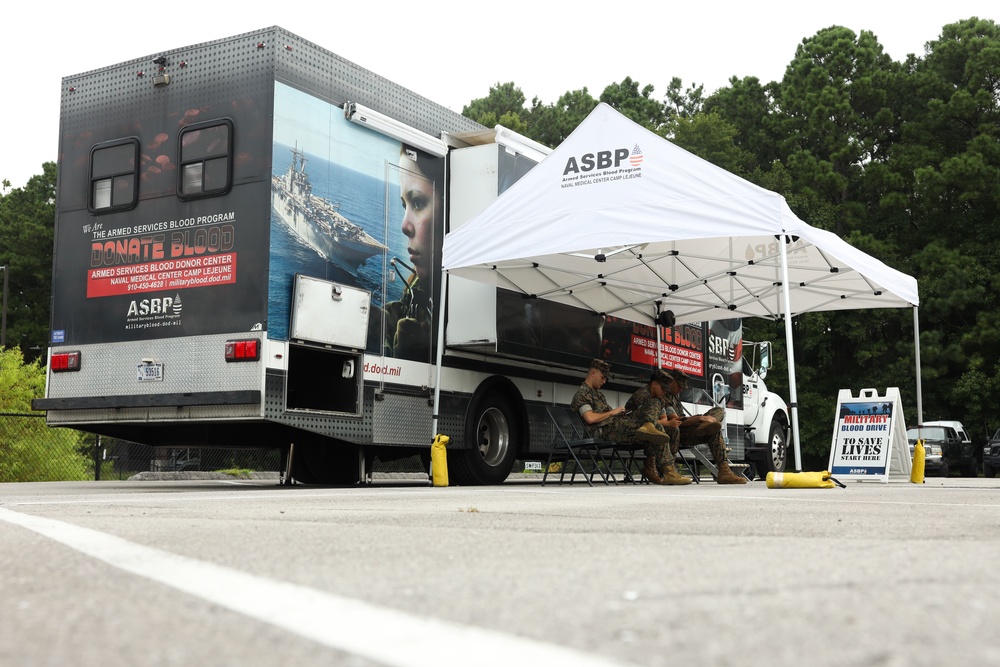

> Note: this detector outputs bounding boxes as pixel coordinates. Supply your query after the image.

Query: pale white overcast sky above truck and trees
[0,0,1000,187]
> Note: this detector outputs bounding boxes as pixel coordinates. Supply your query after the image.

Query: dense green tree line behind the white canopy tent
[463,18,1000,465]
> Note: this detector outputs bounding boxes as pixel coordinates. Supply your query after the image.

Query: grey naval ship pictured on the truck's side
[271,145,385,274]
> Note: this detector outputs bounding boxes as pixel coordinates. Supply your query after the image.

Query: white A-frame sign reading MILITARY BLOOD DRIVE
[829,387,910,483]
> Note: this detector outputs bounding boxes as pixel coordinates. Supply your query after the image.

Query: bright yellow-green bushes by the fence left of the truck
[0,347,94,482]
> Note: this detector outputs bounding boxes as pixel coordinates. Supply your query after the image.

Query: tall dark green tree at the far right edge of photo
[880,18,1000,441]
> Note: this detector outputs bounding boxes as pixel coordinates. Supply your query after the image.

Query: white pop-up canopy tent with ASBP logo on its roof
[439,104,920,469]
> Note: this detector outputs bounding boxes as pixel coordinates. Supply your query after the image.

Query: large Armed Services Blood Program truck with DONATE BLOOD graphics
[34,28,789,484]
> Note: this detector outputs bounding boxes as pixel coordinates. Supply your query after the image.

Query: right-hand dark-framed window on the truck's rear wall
[177,119,233,199]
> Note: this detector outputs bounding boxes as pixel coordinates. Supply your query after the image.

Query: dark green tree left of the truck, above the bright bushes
[0,162,56,360]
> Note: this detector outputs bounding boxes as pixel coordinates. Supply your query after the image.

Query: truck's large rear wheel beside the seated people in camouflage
[448,394,519,486]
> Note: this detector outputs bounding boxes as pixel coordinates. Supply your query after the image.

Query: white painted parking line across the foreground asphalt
[0,508,622,667]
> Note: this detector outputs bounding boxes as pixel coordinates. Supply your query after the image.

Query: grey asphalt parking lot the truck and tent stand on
[0,478,1000,667]
